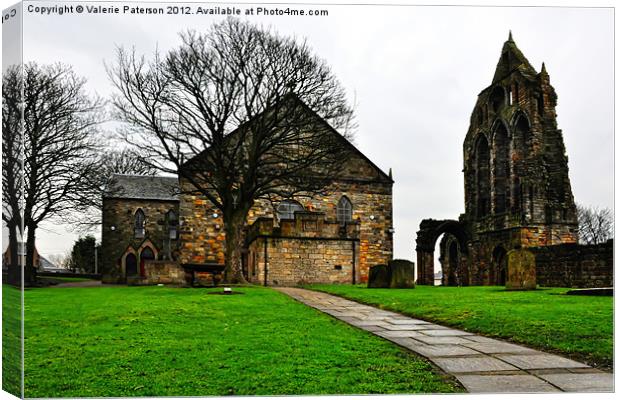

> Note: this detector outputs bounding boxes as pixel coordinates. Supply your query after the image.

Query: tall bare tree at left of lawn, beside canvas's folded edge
[2,63,102,282]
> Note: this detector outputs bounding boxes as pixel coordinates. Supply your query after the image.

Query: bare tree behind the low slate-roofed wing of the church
[67,148,157,233]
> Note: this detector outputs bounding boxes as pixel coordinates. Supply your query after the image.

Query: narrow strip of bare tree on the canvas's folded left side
[2,66,23,285]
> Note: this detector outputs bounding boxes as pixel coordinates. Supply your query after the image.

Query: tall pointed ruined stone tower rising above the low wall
[463,38,577,247]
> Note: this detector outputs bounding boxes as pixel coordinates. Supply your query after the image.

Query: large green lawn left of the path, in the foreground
[25,287,462,397]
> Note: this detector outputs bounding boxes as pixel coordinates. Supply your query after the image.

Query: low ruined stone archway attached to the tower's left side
[416,219,467,285]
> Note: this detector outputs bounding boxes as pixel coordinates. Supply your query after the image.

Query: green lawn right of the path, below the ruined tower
[311,285,613,368]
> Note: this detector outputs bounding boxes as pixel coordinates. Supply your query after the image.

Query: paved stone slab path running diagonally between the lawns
[277,288,613,393]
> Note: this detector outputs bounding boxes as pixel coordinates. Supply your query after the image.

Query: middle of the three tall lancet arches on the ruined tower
[493,123,510,214]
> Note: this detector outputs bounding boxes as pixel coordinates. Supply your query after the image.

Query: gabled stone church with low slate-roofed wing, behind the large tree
[102,101,393,285]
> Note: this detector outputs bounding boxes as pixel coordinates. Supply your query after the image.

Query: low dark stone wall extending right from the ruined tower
[528,240,614,288]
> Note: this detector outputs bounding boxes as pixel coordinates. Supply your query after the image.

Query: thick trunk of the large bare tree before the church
[222,210,248,284]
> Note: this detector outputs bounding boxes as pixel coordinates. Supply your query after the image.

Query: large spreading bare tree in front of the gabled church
[108,18,353,282]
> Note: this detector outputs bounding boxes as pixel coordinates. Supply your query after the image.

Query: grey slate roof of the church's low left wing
[103,174,179,201]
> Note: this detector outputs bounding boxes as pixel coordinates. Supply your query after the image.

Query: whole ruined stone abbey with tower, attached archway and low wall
[416,35,613,286]
